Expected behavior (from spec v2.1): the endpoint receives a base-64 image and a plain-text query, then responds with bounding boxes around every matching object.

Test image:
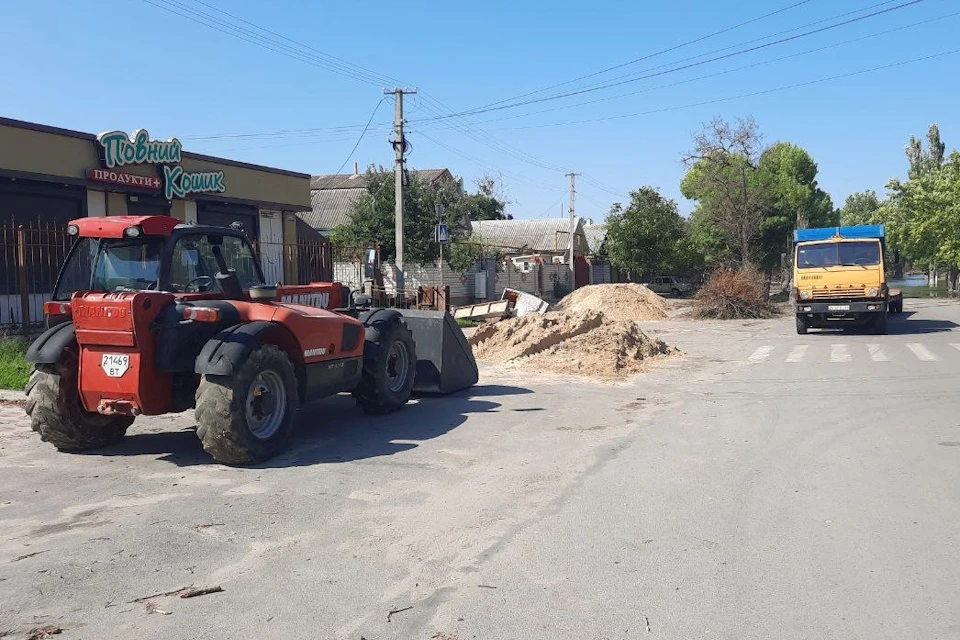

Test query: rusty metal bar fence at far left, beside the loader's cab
[0,220,71,333]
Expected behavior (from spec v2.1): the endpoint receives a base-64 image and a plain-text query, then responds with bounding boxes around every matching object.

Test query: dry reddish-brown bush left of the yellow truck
[693,267,777,320]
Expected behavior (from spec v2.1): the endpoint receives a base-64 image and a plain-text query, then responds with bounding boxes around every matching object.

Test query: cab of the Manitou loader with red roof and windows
[53,216,264,302]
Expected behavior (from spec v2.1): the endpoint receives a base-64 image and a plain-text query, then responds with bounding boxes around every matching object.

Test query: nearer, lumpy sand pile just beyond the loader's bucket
[470,311,679,380]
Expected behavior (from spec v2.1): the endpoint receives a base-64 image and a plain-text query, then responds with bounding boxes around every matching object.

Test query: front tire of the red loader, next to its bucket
[353,319,417,414]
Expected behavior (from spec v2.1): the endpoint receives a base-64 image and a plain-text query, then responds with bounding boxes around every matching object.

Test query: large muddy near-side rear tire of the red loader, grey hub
[194,344,298,465]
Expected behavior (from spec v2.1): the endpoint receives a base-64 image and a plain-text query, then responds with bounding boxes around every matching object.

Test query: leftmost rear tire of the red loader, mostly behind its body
[24,349,133,451]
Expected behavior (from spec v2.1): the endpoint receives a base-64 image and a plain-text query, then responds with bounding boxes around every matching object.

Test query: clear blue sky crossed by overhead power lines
[0,0,960,219]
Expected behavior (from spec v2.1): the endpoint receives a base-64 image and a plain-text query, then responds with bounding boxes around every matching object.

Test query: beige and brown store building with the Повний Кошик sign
[0,118,311,284]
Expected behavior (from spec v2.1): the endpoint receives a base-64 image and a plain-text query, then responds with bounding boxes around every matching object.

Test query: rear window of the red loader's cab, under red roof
[53,238,163,300]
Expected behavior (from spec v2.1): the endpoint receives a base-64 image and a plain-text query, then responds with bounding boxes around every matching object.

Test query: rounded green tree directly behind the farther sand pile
[606,187,684,275]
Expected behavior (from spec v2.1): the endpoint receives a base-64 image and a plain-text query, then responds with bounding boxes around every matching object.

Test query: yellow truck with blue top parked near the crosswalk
[793,225,903,335]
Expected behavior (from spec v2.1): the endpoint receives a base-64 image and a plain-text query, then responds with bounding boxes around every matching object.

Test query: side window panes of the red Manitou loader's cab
[170,234,263,293]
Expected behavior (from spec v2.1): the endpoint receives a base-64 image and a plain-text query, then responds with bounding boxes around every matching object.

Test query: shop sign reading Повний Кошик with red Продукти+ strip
[93,129,227,200]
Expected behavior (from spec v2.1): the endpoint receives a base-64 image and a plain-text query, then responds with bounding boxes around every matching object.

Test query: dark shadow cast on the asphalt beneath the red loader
[83,385,543,469]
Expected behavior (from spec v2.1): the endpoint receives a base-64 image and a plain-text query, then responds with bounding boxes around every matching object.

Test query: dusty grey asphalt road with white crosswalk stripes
[0,301,960,640]
